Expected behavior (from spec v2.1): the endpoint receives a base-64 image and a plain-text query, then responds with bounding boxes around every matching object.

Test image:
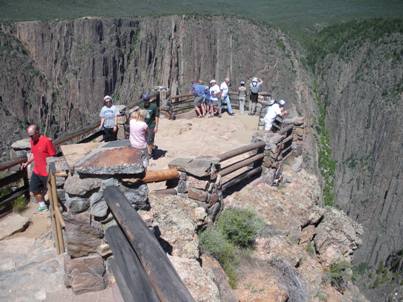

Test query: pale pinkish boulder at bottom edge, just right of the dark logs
[168,256,223,302]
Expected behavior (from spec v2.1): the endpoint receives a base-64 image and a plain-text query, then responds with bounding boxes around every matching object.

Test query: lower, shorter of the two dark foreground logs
[105,226,159,302]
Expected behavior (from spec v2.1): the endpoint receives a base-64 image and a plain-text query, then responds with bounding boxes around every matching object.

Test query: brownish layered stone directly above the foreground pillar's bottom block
[63,212,103,258]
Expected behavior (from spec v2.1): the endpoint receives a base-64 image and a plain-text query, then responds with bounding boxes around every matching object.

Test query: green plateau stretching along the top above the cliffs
[0,0,403,44]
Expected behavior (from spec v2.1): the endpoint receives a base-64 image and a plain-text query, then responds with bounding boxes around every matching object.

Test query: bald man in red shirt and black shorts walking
[22,125,56,211]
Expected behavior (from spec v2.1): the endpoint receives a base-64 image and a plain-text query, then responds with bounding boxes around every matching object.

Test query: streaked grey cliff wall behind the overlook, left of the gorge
[0,16,309,156]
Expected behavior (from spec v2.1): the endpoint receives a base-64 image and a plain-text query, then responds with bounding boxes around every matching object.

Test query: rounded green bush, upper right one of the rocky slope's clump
[217,209,264,248]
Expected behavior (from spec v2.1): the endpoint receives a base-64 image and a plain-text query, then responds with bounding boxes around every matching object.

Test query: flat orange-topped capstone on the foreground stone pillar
[75,142,144,176]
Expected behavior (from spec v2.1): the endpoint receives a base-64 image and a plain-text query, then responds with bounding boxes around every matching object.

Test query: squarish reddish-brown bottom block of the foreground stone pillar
[64,255,106,294]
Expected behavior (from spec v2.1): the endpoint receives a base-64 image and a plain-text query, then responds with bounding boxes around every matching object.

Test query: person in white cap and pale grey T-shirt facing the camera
[99,95,119,142]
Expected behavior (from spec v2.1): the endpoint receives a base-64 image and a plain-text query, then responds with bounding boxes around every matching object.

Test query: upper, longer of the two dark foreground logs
[104,187,194,302]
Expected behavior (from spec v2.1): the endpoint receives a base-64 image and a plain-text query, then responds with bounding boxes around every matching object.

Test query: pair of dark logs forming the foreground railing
[103,187,194,302]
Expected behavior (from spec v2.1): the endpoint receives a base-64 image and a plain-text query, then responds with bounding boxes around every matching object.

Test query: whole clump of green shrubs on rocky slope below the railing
[200,209,264,288]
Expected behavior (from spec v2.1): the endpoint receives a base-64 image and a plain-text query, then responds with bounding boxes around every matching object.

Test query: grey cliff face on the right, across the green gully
[316,21,403,266]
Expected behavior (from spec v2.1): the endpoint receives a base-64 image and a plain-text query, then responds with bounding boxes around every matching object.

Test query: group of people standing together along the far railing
[192,77,263,117]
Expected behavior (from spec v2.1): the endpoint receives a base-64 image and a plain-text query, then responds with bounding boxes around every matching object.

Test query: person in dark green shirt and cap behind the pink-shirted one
[142,93,160,157]
